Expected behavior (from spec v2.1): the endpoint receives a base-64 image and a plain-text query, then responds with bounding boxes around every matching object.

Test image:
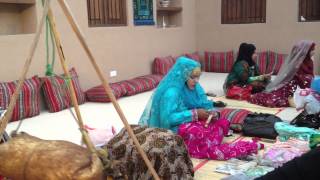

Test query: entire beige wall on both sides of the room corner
[0,0,320,89]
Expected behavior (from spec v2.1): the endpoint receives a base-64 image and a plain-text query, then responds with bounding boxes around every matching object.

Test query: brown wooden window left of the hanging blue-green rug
[87,0,127,27]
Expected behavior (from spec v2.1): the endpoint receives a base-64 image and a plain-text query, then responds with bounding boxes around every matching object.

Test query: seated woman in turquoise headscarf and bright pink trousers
[139,57,260,160]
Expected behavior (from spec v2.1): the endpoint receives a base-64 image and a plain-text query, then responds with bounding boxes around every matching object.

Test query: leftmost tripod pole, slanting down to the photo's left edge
[0,0,50,136]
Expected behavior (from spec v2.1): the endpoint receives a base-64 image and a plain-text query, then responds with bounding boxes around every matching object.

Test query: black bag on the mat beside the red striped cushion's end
[242,113,282,139]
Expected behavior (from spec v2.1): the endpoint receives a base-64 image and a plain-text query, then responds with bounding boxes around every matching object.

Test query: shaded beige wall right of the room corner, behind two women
[196,0,320,73]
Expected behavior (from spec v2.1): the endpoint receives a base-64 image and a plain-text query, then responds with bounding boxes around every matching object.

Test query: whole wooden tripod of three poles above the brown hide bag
[0,0,160,180]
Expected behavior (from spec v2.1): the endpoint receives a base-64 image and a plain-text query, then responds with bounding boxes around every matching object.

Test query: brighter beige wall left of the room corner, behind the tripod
[0,0,196,89]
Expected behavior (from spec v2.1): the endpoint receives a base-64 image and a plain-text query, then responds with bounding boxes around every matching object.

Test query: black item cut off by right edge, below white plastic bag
[290,111,320,129]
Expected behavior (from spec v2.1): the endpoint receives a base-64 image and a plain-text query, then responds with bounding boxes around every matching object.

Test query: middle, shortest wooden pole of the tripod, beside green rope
[48,8,97,155]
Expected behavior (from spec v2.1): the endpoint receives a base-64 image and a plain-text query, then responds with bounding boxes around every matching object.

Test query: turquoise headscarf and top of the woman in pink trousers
[139,57,212,131]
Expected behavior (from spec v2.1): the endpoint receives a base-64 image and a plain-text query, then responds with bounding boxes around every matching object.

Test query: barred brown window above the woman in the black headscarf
[221,0,266,24]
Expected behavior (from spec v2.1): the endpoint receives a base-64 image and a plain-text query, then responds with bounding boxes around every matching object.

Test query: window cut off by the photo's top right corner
[299,0,320,21]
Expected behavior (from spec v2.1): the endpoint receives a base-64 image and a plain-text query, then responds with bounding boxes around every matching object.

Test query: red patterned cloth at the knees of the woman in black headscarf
[226,85,252,100]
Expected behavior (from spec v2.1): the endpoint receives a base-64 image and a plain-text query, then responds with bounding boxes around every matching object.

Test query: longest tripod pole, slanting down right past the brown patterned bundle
[58,0,160,180]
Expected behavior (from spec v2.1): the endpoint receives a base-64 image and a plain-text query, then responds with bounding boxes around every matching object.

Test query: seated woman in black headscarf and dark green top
[223,43,271,98]
